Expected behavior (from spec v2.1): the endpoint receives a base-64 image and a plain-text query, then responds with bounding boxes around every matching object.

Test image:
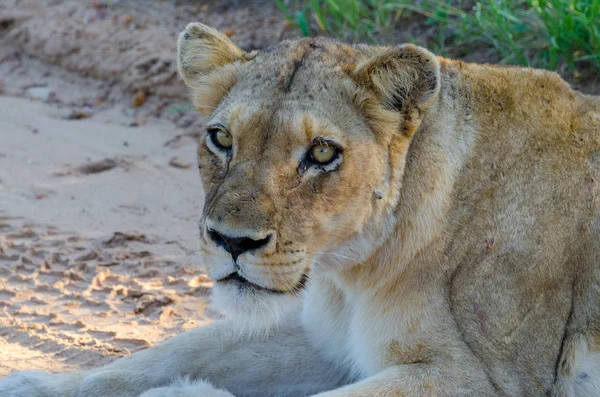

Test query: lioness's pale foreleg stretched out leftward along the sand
[0,317,344,397]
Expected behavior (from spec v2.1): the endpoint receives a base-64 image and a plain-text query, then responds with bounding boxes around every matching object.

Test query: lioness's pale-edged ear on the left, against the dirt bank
[177,23,245,86]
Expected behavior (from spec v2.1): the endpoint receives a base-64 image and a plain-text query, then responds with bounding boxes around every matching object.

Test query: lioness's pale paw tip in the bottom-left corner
[0,371,77,397]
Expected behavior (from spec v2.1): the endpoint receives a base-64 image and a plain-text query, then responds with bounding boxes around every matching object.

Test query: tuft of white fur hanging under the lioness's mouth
[211,283,300,335]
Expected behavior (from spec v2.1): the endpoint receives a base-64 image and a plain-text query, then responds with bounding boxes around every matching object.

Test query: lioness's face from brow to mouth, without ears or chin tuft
[198,84,387,302]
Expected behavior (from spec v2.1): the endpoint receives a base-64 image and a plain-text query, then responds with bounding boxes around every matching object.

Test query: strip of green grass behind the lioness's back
[275,0,600,75]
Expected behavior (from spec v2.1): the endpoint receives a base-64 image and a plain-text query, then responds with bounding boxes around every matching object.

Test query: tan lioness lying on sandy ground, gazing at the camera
[0,23,600,397]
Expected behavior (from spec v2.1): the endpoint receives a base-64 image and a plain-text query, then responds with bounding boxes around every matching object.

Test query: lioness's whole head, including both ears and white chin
[178,24,438,324]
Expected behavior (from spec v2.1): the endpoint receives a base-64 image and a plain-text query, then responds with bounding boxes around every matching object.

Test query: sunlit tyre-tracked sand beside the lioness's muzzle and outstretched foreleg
[0,220,212,376]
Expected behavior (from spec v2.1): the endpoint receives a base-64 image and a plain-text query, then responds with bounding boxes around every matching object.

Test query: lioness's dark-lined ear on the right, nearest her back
[351,44,440,135]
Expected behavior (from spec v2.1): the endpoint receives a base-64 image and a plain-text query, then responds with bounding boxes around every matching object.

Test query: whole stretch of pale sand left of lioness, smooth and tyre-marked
[0,97,211,376]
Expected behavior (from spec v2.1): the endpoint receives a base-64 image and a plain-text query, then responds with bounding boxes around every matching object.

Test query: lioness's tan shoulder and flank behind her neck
[436,61,600,394]
